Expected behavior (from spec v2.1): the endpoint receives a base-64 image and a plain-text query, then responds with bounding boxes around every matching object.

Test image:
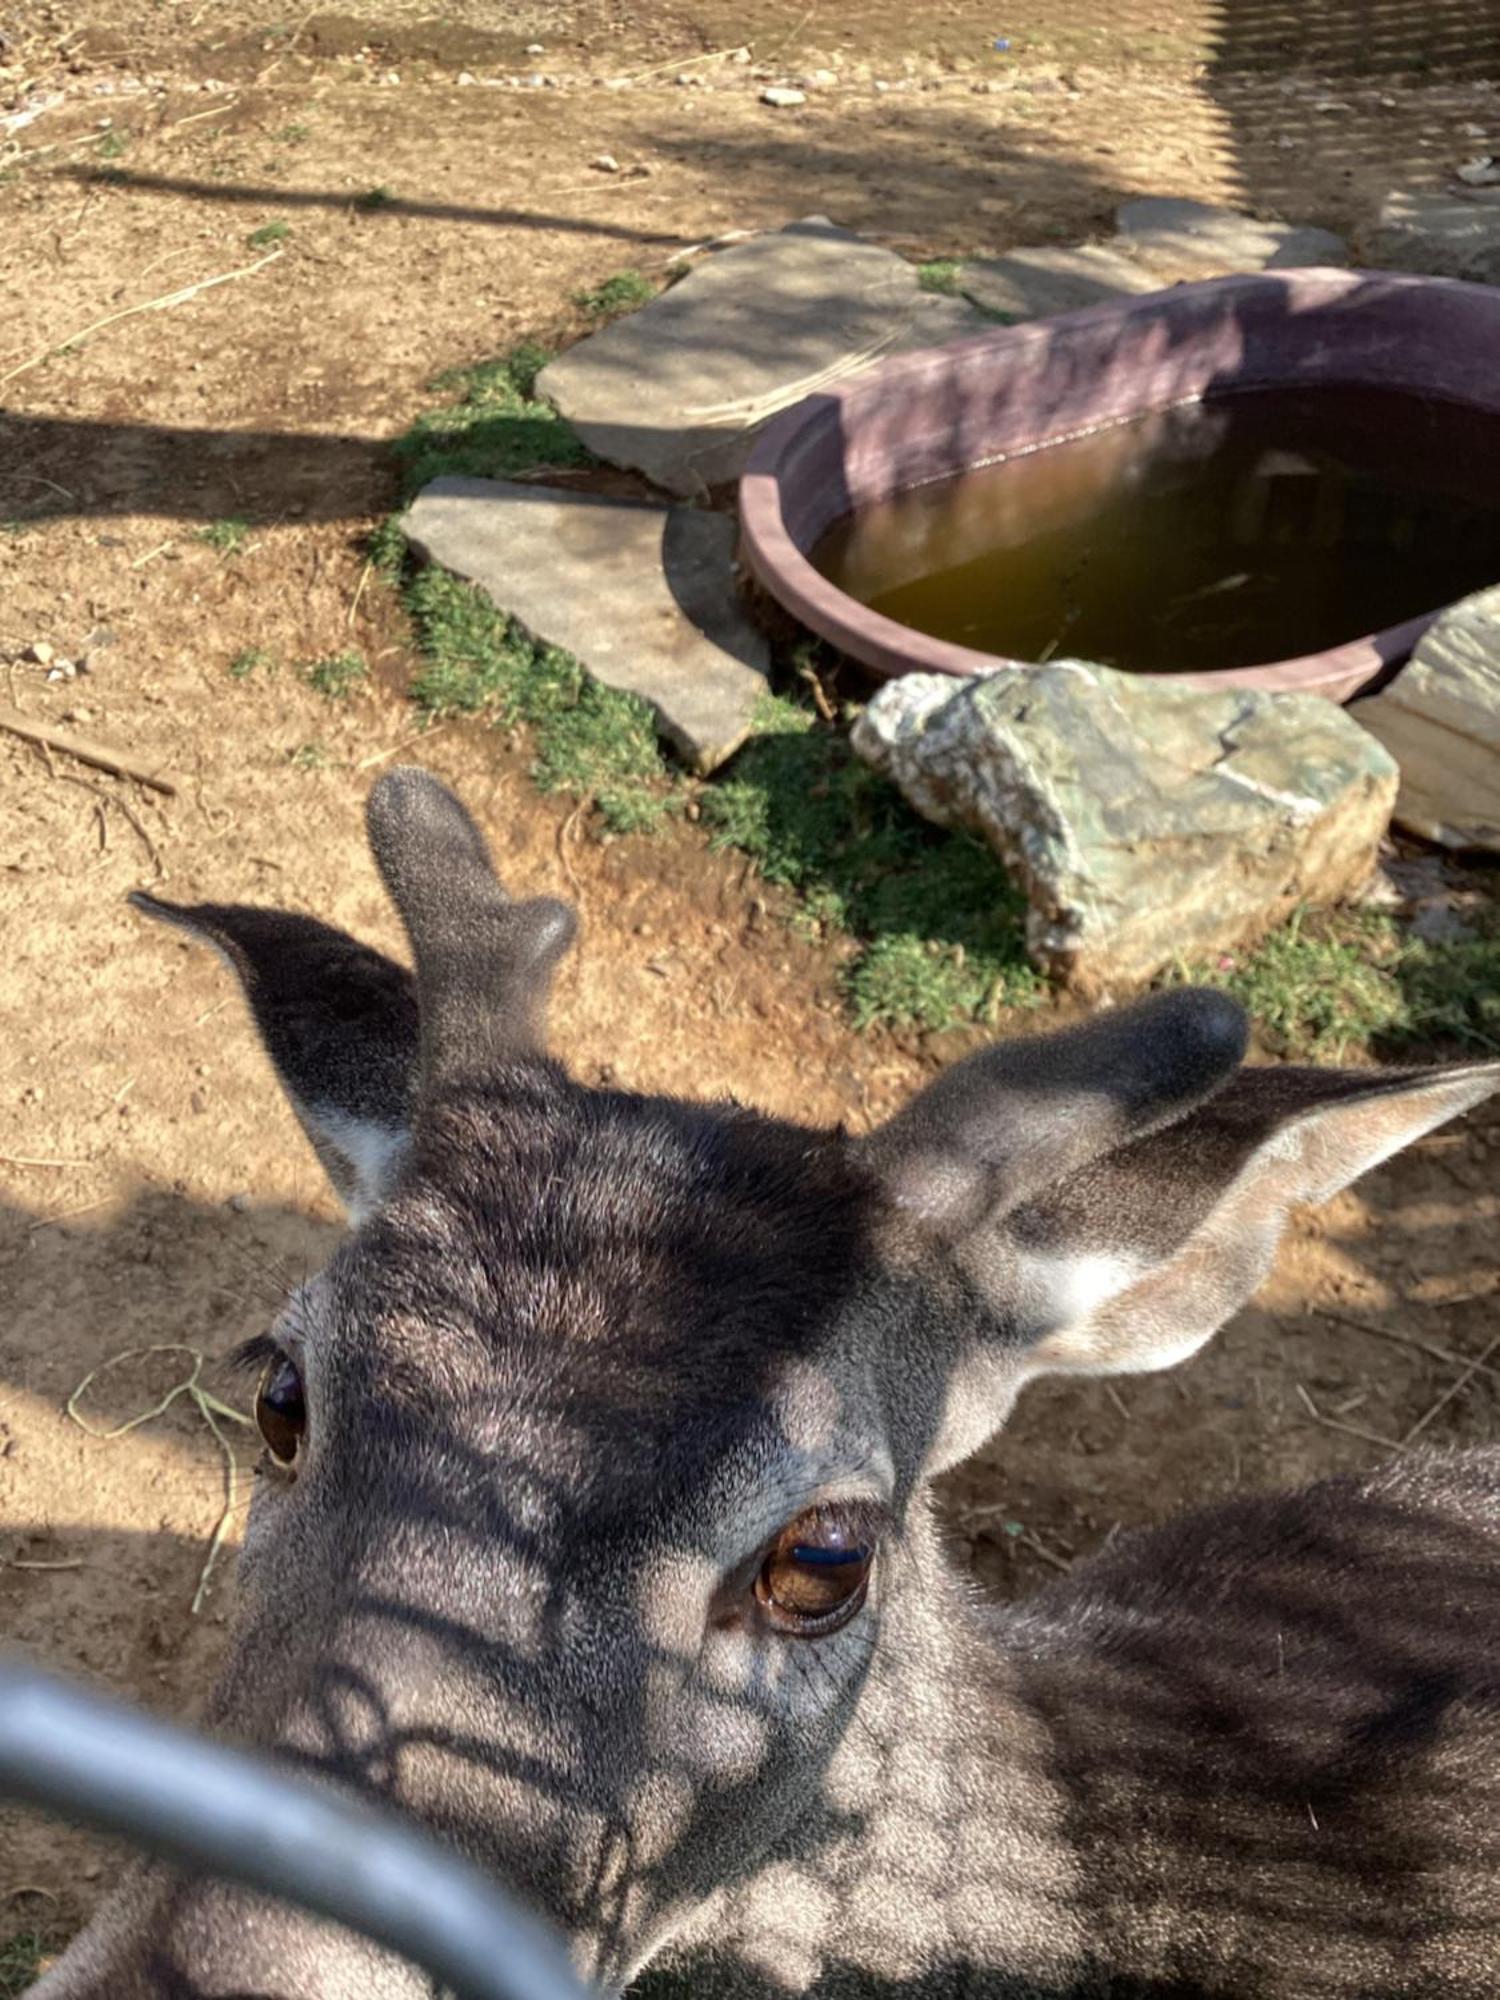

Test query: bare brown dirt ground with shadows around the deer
[0,0,1500,1968]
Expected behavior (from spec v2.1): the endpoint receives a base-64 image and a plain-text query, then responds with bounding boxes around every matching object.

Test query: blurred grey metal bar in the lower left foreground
[0,1660,586,2000]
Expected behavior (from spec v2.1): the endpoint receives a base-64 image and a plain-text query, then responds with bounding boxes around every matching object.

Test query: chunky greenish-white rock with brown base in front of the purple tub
[854,660,1396,996]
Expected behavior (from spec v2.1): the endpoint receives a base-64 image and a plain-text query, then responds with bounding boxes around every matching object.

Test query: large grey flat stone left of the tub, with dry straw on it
[538,218,940,496]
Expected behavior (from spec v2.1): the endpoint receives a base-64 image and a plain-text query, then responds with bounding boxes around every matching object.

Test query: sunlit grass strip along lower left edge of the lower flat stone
[406,568,682,834]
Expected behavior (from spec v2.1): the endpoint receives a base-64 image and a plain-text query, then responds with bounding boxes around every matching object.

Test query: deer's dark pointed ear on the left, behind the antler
[130,890,418,1222]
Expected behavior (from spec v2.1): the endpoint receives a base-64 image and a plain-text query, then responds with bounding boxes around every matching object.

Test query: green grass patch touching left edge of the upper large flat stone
[396,346,594,500]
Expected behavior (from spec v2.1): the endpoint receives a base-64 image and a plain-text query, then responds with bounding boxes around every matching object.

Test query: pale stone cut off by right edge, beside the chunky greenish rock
[1352,586,1500,854]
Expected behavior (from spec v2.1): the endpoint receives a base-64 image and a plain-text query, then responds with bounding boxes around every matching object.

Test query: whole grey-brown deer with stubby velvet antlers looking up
[38,770,1500,2000]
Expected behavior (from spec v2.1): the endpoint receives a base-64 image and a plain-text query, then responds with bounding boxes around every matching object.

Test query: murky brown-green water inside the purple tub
[814,390,1500,674]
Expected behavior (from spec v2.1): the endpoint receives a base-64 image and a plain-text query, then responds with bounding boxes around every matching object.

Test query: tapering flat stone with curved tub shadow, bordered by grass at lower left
[402,478,770,772]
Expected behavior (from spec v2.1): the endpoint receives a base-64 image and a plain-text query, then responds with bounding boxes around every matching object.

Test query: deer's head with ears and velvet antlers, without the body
[35,770,1496,2000]
